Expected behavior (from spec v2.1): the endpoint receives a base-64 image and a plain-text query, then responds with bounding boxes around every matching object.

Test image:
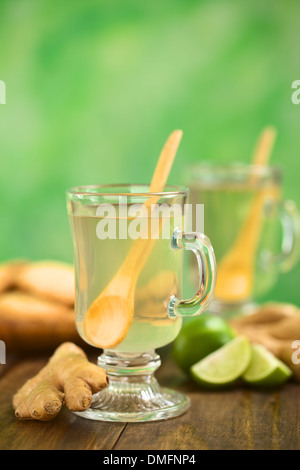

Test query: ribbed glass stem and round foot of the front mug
[76,350,190,422]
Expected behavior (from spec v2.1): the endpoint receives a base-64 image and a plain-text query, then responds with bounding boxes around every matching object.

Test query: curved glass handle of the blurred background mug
[262,201,300,272]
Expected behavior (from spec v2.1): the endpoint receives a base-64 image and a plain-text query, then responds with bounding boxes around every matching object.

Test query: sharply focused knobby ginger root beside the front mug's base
[13,343,108,421]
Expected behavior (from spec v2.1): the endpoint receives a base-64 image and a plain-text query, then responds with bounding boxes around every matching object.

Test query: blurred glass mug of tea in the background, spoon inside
[188,164,300,314]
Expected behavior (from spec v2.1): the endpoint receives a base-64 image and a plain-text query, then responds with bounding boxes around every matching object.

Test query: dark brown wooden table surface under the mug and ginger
[0,350,300,450]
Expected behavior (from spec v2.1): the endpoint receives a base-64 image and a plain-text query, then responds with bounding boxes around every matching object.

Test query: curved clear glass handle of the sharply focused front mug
[168,230,217,318]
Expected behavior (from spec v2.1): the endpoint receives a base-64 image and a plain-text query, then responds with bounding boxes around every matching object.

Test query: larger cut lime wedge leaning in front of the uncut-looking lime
[191,336,251,388]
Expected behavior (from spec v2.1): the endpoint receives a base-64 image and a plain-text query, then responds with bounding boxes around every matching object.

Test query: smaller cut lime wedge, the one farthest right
[243,344,292,387]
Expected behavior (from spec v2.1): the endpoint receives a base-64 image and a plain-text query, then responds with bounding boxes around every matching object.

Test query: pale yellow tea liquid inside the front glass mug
[70,206,183,354]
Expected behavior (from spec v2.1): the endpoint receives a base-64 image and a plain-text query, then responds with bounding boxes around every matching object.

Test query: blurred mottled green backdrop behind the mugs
[0,0,300,304]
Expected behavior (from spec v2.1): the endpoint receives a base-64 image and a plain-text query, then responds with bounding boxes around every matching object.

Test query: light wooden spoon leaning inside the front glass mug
[84,130,182,348]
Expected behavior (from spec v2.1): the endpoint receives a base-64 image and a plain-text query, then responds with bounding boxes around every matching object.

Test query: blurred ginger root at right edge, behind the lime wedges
[229,303,300,382]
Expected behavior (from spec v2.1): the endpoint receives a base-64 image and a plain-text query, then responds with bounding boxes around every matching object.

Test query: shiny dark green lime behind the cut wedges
[172,313,235,373]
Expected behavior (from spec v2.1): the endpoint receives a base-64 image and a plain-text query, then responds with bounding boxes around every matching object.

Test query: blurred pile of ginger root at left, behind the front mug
[0,260,83,352]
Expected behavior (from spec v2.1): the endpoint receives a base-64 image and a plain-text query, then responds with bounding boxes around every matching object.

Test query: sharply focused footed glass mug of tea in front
[67,185,216,422]
